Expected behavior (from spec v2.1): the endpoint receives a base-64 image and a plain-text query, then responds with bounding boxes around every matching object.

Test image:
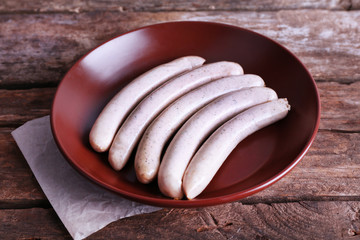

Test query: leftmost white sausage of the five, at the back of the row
[89,56,205,152]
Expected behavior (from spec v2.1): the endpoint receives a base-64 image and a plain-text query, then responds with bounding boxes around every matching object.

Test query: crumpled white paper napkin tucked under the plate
[11,116,160,240]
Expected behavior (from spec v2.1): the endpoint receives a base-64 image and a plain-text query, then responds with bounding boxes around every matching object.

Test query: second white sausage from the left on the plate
[109,62,243,170]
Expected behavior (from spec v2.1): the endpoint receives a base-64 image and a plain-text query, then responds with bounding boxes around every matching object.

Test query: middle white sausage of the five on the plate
[135,74,264,183]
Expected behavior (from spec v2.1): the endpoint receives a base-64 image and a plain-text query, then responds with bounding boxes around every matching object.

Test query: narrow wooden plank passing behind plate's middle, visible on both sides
[0,81,360,132]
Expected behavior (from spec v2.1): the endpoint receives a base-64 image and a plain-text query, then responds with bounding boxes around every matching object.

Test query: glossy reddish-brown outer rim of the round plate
[50,20,321,208]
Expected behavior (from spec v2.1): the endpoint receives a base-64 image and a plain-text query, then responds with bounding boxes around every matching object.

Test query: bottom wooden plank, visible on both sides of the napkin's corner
[0,201,360,240]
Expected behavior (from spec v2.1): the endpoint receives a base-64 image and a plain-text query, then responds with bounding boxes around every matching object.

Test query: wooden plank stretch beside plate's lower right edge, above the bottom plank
[243,131,360,203]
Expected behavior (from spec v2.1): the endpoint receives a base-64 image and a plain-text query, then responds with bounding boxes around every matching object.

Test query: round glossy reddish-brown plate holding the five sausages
[51,22,320,207]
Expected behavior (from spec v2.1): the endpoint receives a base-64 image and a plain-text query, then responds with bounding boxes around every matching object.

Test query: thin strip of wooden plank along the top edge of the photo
[0,0,357,13]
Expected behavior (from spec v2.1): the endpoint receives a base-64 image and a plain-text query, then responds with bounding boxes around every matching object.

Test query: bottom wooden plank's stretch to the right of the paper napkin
[89,202,360,240]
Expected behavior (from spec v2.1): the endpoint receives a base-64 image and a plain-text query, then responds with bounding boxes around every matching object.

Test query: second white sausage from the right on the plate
[158,87,277,199]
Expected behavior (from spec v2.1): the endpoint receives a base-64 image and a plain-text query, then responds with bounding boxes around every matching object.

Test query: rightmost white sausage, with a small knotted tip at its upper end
[183,99,290,199]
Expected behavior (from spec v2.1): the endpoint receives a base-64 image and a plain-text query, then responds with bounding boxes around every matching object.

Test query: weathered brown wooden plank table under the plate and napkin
[0,0,360,239]
